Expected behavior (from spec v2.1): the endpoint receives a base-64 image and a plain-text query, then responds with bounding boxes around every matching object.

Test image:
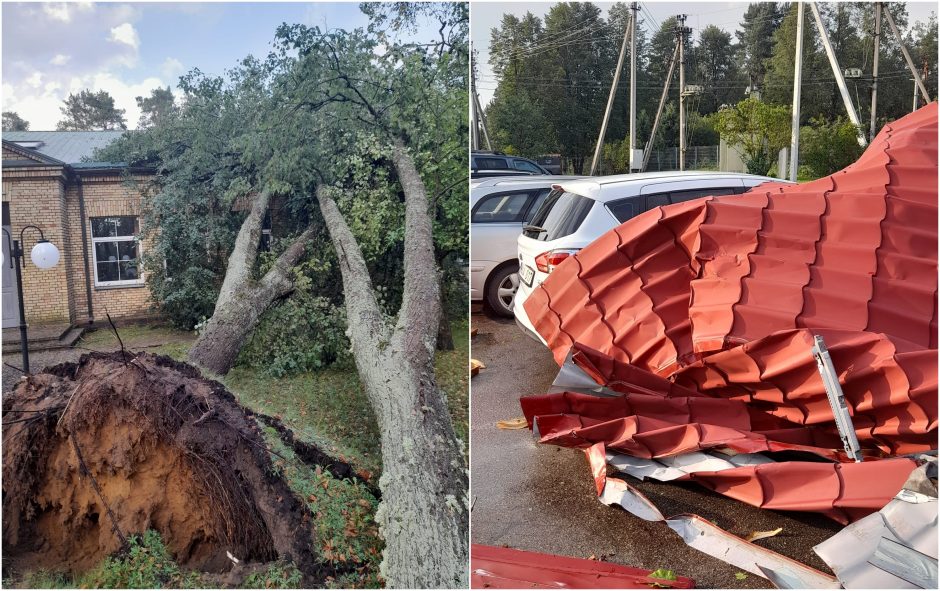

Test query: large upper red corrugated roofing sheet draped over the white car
[524,103,937,376]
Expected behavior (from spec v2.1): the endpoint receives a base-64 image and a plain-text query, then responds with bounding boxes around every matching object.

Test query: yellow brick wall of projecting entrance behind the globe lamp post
[3,167,70,323]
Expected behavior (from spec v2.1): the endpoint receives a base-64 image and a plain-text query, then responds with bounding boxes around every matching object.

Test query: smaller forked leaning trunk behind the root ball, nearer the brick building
[187,192,313,375]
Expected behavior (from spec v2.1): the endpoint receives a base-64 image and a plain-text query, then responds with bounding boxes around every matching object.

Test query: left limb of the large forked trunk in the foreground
[317,186,388,358]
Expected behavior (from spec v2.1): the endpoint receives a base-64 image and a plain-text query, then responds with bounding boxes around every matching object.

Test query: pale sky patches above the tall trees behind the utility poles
[470,0,937,106]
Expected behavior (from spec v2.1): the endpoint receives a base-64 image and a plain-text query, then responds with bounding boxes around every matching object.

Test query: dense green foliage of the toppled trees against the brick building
[98,4,469,373]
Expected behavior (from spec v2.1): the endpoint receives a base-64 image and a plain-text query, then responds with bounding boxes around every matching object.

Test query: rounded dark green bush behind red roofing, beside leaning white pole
[800,117,864,178]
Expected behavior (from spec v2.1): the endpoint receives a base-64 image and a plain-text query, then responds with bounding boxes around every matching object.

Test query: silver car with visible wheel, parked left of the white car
[470,175,581,318]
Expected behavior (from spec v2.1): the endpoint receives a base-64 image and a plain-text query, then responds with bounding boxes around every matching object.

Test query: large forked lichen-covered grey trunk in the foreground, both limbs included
[317,142,469,588]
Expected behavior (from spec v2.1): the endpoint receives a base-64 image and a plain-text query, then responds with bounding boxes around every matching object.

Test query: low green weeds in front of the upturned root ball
[78,530,198,589]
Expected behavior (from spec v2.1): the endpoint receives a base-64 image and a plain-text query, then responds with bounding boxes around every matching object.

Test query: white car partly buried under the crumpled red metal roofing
[516,171,784,344]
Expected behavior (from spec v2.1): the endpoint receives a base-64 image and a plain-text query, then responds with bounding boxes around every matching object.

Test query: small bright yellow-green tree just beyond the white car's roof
[710,98,790,175]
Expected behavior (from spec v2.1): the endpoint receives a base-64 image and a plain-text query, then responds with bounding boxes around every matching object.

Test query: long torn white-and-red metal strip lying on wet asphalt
[585,443,839,589]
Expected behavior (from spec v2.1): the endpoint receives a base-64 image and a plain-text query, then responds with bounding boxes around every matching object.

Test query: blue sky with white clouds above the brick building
[2,2,384,131]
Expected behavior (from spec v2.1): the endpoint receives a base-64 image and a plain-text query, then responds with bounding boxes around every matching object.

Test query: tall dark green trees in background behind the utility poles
[480,2,938,173]
